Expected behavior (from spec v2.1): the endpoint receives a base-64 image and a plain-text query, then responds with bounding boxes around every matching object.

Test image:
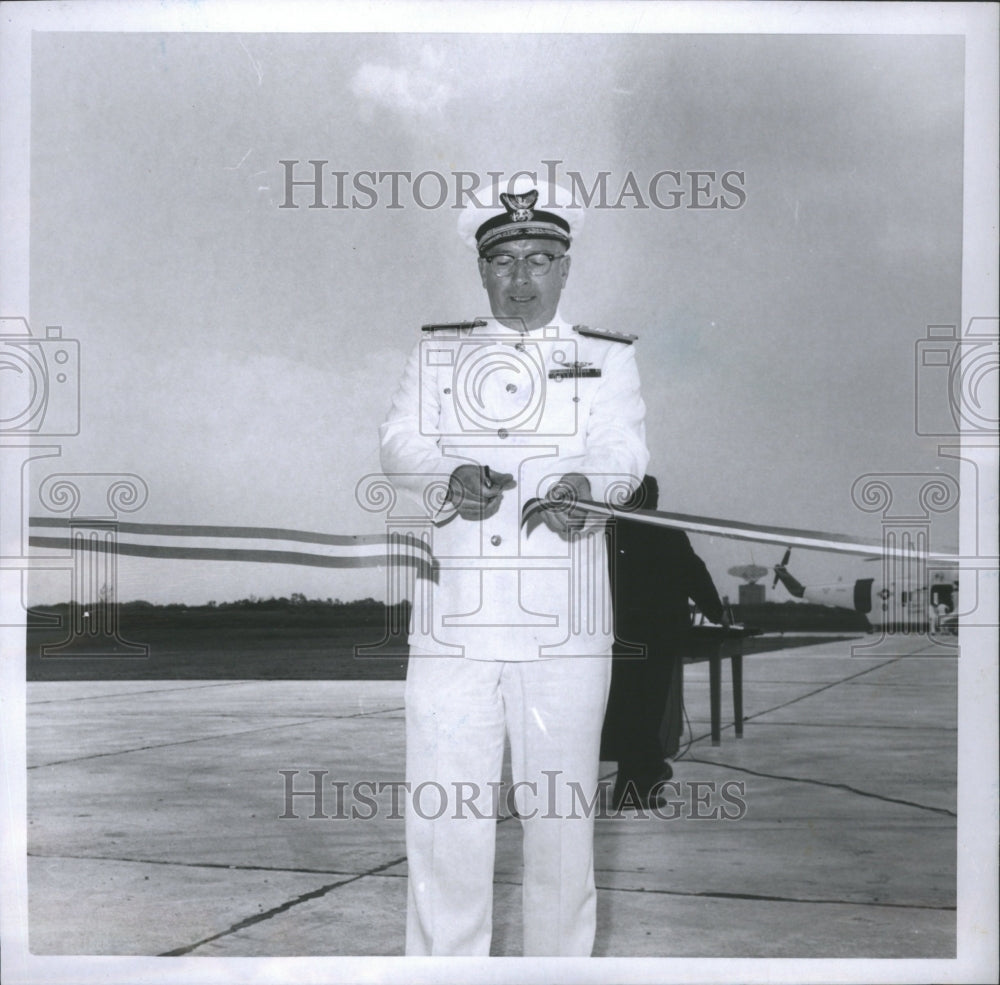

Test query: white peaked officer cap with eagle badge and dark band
[458,173,584,254]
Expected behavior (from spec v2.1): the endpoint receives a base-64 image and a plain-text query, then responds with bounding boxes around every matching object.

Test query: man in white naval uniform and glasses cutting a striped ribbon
[381,179,648,955]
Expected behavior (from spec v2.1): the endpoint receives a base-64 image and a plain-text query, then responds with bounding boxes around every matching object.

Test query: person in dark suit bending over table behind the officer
[601,475,727,811]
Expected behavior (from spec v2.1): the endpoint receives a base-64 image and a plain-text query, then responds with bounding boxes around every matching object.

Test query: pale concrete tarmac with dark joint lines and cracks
[27,639,958,956]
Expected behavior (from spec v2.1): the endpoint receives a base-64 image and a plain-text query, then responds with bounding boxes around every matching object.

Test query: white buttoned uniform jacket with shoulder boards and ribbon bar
[381,316,649,660]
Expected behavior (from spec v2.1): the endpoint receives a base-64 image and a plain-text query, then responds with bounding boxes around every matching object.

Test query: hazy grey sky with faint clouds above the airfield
[21,32,964,604]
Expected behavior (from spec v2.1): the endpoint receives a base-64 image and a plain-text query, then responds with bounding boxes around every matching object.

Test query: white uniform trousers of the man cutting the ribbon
[406,649,611,956]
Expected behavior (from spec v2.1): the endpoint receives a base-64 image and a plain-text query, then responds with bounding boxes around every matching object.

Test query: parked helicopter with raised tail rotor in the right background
[771,547,958,633]
